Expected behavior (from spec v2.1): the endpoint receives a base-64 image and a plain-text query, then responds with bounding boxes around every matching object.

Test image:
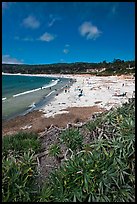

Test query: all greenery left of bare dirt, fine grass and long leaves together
[2,133,40,202]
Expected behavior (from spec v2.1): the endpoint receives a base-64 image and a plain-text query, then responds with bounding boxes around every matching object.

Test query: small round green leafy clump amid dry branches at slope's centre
[60,128,83,151]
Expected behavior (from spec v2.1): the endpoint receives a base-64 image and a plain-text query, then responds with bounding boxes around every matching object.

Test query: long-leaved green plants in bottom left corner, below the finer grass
[2,151,37,202]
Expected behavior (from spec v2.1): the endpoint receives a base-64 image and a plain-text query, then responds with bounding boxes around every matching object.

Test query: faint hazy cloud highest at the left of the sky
[22,15,40,29]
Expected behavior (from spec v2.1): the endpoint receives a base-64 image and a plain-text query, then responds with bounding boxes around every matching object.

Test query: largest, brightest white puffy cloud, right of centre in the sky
[79,22,102,40]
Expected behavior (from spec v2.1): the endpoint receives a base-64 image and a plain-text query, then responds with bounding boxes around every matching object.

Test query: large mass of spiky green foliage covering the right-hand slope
[41,100,135,202]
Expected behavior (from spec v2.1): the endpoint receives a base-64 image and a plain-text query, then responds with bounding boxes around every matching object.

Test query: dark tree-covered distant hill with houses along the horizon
[2,59,135,75]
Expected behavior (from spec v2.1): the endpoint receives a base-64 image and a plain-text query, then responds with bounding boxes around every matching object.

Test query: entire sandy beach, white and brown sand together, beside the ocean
[2,74,135,135]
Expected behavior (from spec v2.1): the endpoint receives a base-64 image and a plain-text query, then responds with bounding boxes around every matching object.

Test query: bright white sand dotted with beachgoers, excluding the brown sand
[40,75,135,117]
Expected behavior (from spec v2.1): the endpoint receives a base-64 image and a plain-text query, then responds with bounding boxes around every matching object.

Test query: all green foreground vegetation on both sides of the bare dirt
[2,99,135,202]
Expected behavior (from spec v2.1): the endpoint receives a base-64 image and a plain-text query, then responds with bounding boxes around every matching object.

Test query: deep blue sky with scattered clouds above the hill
[2,2,135,64]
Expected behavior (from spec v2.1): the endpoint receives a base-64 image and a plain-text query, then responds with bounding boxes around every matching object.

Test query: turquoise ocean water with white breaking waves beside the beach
[2,74,70,120]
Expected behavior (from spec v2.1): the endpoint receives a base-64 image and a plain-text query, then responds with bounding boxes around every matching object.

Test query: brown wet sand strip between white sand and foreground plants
[2,106,105,136]
